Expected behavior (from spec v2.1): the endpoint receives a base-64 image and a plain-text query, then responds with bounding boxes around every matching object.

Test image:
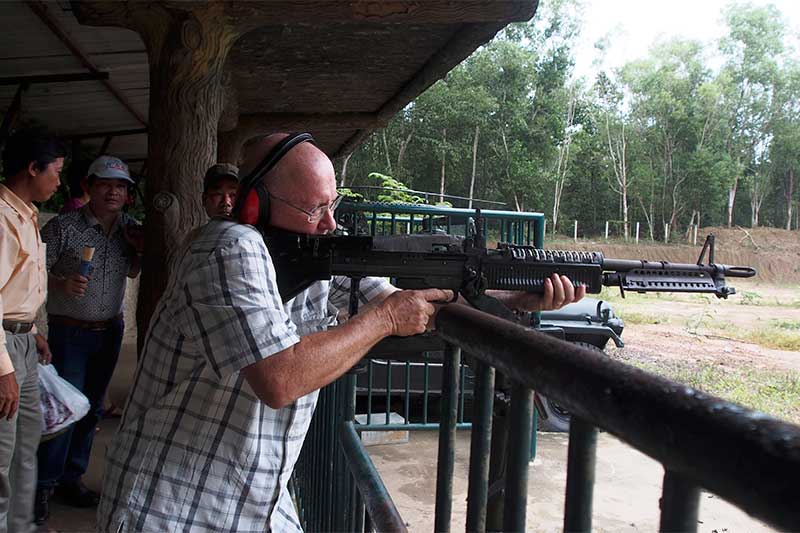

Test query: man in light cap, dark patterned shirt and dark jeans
[34,155,143,524]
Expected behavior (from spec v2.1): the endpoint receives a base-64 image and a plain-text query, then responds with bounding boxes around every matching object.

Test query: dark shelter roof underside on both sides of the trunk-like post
[0,0,537,174]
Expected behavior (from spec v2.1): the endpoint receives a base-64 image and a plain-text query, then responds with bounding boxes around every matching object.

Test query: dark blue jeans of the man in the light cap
[38,320,125,488]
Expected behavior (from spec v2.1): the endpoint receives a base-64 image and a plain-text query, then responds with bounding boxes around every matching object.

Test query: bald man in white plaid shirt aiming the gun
[98,134,583,532]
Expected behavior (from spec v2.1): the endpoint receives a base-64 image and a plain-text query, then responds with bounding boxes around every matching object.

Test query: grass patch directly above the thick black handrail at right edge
[617,356,800,424]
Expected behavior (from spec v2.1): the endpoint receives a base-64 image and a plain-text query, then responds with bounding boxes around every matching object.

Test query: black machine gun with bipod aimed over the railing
[264,224,756,319]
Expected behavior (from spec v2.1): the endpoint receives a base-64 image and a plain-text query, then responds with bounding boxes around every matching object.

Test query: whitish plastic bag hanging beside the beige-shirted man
[39,364,89,435]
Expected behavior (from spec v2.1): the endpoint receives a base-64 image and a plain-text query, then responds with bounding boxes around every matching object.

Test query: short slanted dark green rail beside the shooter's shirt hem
[339,421,408,532]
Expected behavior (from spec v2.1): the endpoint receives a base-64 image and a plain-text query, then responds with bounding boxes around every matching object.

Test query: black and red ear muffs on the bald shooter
[233,133,316,229]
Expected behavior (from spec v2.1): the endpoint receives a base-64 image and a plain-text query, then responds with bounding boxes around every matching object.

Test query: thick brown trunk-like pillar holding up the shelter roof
[136,10,237,348]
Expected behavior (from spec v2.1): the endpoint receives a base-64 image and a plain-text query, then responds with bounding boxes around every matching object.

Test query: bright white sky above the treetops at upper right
[568,0,800,79]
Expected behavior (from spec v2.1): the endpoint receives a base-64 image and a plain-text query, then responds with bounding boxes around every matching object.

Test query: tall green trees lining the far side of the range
[340,0,800,238]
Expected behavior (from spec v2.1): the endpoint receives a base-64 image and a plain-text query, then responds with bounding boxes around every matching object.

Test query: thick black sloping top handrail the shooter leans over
[436,305,800,530]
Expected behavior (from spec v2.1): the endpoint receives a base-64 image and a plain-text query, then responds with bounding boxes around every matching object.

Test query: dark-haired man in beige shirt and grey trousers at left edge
[0,130,65,533]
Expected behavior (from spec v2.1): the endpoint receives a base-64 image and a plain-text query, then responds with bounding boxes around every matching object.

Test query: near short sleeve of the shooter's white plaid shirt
[180,233,300,379]
